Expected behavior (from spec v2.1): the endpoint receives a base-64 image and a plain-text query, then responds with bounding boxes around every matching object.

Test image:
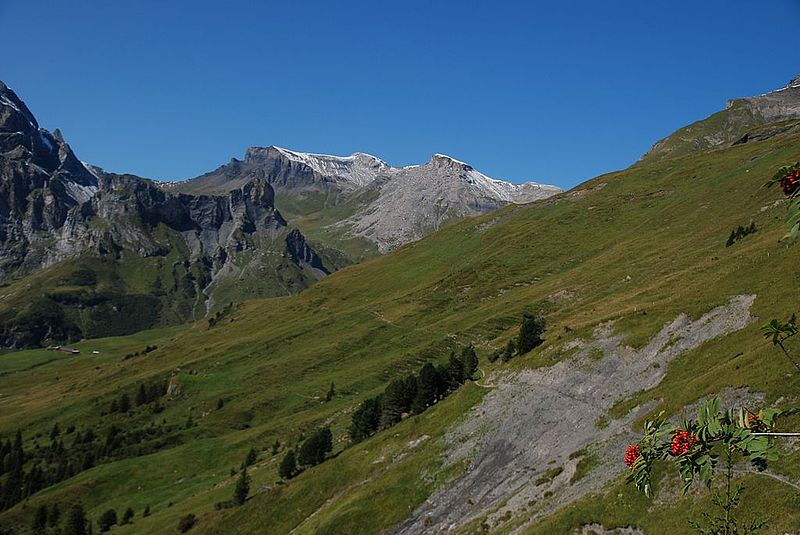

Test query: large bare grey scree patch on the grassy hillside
[394,295,755,534]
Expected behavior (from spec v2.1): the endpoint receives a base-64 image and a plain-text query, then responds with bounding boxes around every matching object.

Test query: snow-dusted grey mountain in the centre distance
[175,147,561,254]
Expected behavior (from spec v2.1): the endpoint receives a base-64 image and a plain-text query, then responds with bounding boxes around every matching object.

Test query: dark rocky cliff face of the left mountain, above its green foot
[0,82,329,345]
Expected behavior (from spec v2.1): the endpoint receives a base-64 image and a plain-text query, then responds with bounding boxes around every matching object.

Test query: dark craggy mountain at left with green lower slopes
[0,79,330,347]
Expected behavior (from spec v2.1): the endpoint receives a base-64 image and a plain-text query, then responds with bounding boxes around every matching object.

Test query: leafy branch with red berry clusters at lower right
[624,398,781,496]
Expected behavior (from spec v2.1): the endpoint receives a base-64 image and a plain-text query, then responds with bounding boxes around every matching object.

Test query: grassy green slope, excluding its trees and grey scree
[0,126,800,533]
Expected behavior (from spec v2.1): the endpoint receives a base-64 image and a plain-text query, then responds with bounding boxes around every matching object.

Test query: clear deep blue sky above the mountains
[0,0,800,186]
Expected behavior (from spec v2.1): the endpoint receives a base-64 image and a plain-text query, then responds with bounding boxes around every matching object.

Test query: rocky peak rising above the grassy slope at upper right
[642,76,800,161]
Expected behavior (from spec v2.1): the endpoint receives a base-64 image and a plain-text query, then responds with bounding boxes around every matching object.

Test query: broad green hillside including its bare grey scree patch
[0,76,800,535]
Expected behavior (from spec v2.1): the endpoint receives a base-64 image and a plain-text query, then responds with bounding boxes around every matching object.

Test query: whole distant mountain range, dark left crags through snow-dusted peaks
[0,82,561,347]
